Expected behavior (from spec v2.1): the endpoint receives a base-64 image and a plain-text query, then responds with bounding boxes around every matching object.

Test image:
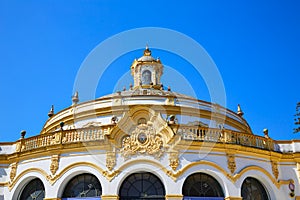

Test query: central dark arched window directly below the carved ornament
[119,172,166,200]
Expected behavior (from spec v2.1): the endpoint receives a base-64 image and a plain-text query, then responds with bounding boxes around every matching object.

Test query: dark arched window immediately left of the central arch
[62,174,102,200]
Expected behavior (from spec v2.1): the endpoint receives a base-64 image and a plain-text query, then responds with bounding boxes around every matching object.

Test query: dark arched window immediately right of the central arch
[182,173,224,200]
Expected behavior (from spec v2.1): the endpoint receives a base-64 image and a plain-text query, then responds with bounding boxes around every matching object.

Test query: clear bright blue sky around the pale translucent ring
[0,0,300,142]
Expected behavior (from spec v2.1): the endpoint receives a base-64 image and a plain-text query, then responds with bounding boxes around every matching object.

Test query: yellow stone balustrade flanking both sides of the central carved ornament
[5,125,280,152]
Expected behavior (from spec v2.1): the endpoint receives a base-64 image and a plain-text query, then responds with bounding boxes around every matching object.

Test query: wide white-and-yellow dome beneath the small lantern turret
[41,86,252,135]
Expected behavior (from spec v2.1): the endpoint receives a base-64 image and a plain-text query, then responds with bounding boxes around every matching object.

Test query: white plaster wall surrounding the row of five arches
[0,150,300,200]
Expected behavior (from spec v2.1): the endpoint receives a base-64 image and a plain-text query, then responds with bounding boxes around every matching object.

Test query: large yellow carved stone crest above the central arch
[120,122,164,159]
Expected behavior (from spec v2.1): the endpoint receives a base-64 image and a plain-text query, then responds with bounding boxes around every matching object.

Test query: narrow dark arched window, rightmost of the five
[242,177,269,200]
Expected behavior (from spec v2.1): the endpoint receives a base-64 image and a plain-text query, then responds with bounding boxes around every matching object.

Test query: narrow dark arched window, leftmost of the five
[20,178,45,200]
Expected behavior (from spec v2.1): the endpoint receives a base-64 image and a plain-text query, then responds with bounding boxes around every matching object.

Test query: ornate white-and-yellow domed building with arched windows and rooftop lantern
[0,48,300,200]
